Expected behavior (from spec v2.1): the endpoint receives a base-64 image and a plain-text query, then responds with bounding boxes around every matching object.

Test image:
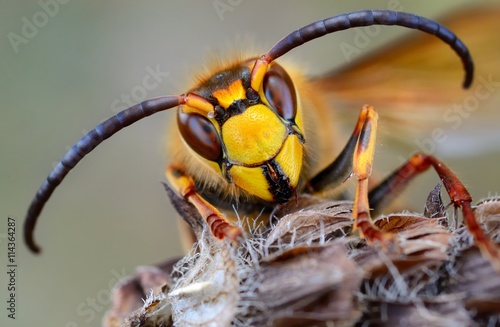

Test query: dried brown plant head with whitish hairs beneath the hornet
[104,188,500,327]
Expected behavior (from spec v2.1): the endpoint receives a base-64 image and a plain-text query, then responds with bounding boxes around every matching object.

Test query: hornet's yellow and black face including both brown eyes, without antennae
[178,63,304,203]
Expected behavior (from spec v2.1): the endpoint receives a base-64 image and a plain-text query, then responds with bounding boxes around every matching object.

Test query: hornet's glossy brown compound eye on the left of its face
[177,109,222,162]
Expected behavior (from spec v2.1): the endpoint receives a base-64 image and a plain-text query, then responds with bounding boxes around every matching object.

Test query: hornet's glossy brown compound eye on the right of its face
[263,64,297,121]
